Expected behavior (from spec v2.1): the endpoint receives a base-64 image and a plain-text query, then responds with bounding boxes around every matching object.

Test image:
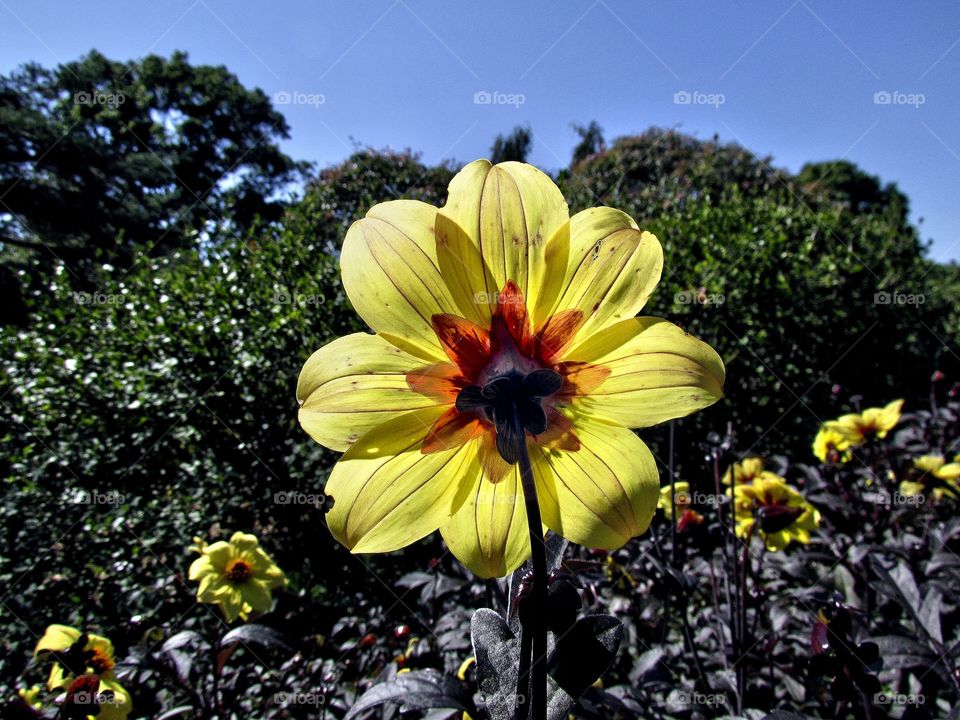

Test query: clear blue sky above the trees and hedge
[0,0,960,260]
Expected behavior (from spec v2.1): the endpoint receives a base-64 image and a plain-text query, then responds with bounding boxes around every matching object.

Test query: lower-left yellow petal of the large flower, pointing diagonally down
[325,408,480,553]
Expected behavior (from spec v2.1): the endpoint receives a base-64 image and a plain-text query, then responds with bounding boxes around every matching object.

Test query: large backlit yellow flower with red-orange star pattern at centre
[297,160,724,577]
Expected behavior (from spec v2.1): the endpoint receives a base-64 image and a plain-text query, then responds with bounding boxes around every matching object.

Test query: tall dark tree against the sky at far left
[0,51,303,284]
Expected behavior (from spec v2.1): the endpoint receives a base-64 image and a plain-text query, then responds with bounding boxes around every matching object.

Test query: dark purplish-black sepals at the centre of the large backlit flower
[456,368,563,465]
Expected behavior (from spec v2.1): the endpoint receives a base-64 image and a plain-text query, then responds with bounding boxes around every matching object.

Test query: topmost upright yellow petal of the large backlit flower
[440,160,569,320]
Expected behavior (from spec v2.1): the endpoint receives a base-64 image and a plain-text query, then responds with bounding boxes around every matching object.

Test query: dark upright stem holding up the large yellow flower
[513,411,547,720]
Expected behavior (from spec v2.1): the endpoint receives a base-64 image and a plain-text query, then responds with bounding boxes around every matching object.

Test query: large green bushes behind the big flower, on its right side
[561,131,960,462]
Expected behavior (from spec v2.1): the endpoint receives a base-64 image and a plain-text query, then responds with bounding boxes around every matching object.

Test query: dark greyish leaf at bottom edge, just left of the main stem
[344,668,477,720]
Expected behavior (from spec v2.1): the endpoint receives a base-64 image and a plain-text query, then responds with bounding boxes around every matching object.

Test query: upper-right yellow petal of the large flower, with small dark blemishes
[552,207,663,338]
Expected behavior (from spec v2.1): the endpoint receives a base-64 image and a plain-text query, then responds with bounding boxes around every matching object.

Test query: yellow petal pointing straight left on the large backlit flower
[297,333,446,452]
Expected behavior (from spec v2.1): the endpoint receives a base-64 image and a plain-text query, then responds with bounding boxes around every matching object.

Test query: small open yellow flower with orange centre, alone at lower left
[190,532,287,622]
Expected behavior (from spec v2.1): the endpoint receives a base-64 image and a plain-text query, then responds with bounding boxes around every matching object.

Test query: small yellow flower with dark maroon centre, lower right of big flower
[734,478,820,551]
